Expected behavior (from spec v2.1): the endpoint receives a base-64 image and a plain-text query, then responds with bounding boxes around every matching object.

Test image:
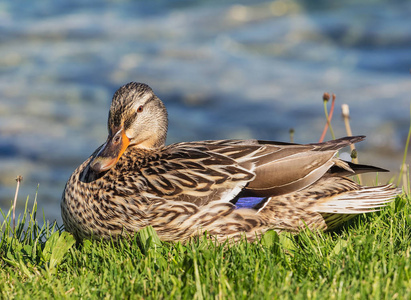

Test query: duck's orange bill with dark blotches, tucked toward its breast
[90,131,130,173]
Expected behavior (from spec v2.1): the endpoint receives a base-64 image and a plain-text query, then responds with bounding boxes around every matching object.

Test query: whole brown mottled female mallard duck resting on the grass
[61,82,398,241]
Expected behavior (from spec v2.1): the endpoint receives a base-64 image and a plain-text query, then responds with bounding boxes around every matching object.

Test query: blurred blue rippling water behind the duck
[0,0,411,224]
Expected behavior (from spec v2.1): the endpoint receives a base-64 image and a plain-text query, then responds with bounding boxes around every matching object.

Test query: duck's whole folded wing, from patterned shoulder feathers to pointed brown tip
[140,137,363,205]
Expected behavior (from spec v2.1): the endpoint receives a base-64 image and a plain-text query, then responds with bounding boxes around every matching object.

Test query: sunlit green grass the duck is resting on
[0,191,411,299]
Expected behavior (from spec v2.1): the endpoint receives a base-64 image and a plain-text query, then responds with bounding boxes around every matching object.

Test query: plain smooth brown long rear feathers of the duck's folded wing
[211,136,365,196]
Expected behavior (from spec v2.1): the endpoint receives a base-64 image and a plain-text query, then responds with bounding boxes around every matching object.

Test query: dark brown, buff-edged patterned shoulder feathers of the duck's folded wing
[138,143,255,206]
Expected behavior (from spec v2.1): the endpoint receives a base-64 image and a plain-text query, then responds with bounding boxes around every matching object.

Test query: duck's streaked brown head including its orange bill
[90,82,168,173]
